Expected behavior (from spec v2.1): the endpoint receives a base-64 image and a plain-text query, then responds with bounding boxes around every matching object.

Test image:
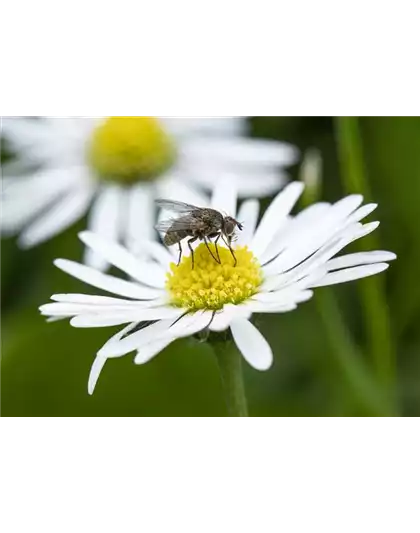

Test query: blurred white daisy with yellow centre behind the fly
[0,112,297,269]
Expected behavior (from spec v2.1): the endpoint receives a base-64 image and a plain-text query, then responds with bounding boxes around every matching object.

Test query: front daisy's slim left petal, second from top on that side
[54,259,162,300]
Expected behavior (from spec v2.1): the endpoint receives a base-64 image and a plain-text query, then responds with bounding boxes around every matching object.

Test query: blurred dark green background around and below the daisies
[0,115,420,419]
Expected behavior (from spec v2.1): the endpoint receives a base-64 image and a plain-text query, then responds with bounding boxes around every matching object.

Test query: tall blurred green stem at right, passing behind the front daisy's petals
[335,115,396,389]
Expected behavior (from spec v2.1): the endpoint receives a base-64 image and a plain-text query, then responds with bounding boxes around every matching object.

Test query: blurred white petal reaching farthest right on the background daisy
[181,137,299,166]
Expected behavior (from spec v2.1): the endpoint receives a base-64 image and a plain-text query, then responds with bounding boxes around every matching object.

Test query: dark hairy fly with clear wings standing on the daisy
[156,200,242,268]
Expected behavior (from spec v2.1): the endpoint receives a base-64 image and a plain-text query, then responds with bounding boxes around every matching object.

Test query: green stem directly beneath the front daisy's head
[211,340,248,422]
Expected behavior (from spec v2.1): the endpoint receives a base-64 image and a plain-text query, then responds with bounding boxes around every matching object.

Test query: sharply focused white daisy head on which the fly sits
[40,182,396,394]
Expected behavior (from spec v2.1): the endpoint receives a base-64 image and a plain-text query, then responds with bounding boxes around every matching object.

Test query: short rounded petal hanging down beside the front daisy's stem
[230,318,273,370]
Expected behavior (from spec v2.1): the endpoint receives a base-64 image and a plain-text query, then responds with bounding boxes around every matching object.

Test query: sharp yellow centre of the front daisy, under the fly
[166,244,262,311]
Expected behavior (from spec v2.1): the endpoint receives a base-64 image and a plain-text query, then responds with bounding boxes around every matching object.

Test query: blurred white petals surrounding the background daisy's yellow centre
[1,112,298,271]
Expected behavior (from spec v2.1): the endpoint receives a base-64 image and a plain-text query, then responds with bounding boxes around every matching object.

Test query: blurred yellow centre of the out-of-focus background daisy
[88,116,176,184]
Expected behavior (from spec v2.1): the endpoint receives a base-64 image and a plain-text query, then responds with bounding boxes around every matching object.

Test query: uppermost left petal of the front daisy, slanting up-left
[79,231,165,289]
